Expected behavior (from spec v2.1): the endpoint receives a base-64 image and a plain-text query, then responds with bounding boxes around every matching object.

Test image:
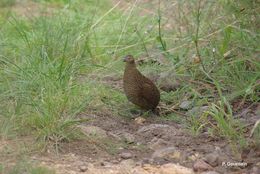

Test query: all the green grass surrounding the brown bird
[0,0,260,154]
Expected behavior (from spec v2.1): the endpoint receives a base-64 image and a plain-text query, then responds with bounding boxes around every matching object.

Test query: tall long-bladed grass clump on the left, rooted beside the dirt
[1,10,95,142]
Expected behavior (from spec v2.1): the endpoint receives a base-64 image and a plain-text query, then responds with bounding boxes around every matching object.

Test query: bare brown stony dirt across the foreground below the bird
[0,1,260,174]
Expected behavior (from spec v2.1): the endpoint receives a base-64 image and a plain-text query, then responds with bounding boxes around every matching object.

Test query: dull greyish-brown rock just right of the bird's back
[158,71,181,92]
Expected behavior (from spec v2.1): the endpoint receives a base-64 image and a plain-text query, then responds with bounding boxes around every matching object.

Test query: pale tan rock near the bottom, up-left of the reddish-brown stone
[152,147,180,159]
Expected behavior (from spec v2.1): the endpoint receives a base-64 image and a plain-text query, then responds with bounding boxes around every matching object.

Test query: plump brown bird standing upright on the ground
[123,55,160,115]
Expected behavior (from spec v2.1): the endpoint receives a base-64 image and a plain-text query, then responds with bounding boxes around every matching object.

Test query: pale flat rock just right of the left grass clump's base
[78,125,107,138]
